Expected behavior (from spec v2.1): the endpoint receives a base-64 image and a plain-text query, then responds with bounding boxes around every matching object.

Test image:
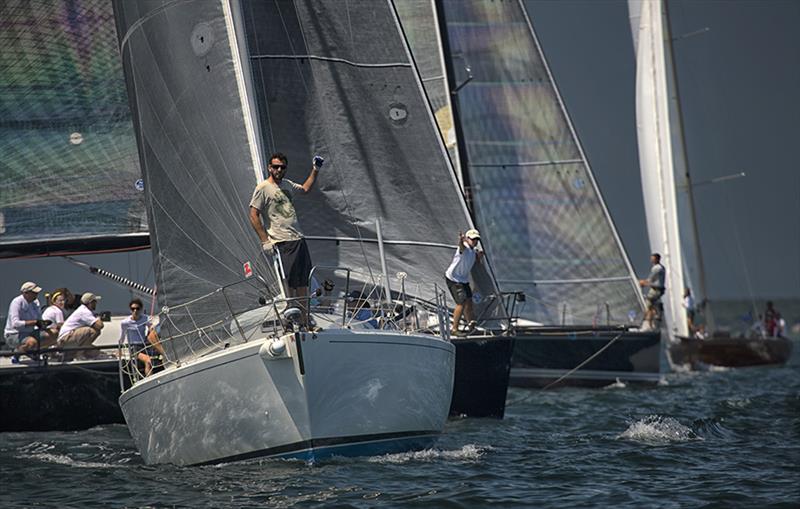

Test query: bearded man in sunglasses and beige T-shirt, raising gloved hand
[250,152,324,324]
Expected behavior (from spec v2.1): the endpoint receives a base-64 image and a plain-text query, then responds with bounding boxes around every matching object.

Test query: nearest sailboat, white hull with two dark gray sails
[114,0,502,465]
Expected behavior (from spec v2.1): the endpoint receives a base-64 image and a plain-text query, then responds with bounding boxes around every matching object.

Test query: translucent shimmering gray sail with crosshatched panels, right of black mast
[434,0,642,324]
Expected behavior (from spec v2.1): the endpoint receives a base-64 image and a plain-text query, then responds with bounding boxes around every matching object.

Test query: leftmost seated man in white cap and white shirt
[3,281,56,353]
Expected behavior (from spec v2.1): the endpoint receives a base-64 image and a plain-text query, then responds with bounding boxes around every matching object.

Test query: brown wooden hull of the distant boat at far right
[667,336,792,369]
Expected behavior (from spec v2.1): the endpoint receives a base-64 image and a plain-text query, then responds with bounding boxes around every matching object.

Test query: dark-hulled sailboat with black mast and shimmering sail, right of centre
[404,0,661,387]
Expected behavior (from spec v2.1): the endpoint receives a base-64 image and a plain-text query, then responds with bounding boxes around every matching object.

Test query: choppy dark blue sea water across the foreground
[0,341,800,508]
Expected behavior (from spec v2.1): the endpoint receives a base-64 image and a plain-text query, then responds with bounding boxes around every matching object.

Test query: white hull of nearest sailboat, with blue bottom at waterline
[120,329,455,465]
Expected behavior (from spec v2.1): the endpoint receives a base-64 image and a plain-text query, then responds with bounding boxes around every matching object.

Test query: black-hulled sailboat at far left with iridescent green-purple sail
[0,2,149,431]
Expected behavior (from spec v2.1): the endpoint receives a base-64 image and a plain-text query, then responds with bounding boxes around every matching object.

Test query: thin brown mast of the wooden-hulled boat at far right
[661,0,714,331]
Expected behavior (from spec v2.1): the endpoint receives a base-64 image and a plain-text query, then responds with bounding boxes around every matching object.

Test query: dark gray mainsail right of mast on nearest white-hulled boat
[242,0,504,318]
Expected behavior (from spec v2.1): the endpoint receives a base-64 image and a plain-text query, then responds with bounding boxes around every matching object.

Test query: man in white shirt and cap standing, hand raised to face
[444,228,483,335]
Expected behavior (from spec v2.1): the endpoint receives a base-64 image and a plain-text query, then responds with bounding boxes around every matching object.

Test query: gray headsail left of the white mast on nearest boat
[114,1,279,361]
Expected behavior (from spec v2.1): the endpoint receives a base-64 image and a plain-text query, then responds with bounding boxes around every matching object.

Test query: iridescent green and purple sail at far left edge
[0,0,149,257]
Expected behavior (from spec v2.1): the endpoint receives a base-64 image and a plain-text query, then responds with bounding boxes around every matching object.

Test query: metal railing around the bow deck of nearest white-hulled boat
[115,266,460,385]
